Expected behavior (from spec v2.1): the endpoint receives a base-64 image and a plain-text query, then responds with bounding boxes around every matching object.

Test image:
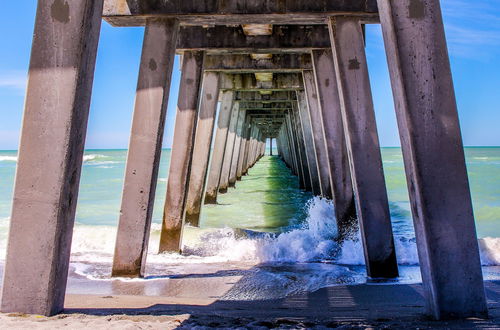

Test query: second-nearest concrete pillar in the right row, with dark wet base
[329,18,398,278]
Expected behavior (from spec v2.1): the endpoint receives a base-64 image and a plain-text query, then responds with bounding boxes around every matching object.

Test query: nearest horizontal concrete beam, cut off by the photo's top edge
[103,0,378,26]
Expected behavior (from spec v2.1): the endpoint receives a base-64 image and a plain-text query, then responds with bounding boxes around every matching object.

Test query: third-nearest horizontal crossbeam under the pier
[204,54,312,73]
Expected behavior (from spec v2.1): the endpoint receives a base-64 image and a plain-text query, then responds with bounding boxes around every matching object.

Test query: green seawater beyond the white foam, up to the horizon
[0,147,500,237]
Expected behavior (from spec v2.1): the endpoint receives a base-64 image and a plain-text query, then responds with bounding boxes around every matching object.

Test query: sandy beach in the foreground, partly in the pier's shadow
[0,282,500,330]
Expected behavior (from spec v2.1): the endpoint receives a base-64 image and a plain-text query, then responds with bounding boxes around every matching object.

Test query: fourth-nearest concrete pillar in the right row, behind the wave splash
[302,70,333,199]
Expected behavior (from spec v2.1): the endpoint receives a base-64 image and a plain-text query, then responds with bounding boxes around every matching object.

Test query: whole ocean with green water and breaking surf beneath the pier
[0,147,500,300]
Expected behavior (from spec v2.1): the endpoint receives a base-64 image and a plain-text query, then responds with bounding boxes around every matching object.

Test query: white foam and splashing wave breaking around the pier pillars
[0,198,500,279]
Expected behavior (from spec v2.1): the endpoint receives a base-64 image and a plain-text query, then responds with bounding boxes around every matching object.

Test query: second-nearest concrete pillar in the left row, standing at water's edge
[111,19,179,277]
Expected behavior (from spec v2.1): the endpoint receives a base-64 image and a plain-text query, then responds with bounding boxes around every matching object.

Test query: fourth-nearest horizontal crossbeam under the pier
[221,73,304,92]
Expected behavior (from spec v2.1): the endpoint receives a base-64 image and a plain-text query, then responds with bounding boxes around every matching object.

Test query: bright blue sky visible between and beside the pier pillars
[0,0,500,150]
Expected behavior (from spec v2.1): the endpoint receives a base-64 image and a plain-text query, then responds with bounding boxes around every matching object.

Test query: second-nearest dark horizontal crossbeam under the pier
[177,25,331,54]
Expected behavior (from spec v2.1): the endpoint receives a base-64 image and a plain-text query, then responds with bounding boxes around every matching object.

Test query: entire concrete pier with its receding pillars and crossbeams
[1,0,487,319]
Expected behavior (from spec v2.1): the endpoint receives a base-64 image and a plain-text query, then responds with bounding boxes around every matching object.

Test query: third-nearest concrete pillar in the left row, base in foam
[159,52,203,252]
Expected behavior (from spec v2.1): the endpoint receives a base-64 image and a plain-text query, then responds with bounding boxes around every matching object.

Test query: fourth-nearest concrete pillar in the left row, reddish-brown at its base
[186,72,219,227]
